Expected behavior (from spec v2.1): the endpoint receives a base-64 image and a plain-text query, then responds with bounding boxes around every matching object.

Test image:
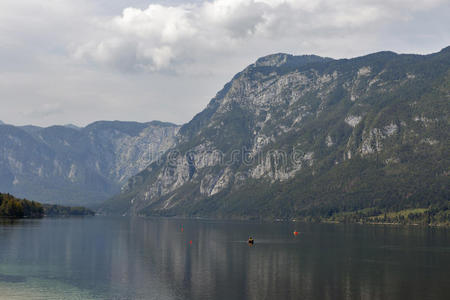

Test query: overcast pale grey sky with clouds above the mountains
[0,0,450,126]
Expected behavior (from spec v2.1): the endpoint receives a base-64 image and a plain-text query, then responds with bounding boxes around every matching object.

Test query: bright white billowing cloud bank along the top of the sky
[74,0,443,72]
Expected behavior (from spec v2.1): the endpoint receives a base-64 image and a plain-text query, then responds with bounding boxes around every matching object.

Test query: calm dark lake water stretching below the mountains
[0,217,450,300]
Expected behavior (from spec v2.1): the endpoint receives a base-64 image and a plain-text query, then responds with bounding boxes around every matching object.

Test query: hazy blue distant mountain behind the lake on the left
[0,121,179,205]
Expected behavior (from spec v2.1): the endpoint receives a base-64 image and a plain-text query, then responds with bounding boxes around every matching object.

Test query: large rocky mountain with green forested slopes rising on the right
[102,47,450,219]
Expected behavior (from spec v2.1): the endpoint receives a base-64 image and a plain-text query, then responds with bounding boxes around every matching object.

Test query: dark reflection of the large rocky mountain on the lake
[109,219,450,299]
